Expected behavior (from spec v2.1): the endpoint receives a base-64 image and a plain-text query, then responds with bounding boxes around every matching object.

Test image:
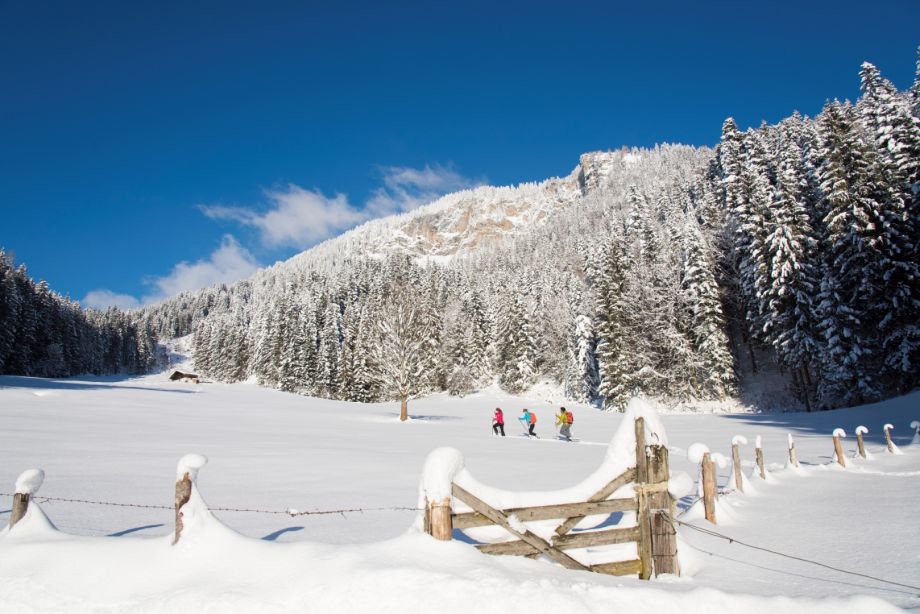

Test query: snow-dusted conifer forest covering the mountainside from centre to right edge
[1,55,920,409]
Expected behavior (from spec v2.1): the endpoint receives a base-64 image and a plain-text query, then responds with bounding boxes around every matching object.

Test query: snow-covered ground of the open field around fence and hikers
[0,375,920,614]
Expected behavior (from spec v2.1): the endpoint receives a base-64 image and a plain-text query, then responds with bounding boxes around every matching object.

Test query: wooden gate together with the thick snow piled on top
[419,399,680,579]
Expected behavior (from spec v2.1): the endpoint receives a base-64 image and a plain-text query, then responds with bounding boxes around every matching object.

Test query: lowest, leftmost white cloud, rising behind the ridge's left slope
[80,235,260,309]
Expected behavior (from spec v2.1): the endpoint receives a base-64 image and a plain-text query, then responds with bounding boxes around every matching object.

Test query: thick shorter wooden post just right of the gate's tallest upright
[637,445,680,576]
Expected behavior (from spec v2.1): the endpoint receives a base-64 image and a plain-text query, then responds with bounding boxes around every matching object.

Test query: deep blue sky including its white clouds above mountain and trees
[0,0,920,305]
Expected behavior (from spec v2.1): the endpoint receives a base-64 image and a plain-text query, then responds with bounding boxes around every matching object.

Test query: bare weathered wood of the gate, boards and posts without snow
[425,418,680,579]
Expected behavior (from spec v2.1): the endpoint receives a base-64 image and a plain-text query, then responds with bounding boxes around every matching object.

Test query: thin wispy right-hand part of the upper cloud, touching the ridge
[365,164,483,217]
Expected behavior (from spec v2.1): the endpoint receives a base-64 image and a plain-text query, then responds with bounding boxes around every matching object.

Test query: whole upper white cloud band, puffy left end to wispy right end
[199,164,482,249]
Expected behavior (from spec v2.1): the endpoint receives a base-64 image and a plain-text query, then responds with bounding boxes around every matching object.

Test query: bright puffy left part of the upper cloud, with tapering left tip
[200,184,367,248]
